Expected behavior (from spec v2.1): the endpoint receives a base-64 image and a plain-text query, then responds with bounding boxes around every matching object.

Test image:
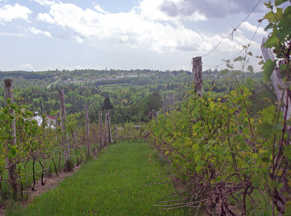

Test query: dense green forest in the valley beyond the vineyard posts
[0,71,272,123]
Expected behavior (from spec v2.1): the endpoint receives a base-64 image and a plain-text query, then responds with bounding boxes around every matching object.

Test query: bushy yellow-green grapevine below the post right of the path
[151,86,280,214]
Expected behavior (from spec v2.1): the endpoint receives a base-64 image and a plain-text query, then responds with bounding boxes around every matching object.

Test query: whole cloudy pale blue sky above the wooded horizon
[0,0,268,71]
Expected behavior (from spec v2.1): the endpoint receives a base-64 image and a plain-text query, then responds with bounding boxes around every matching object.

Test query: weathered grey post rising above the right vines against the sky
[192,57,203,97]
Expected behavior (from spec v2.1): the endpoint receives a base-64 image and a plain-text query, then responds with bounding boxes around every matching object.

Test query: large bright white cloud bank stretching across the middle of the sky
[38,3,226,53]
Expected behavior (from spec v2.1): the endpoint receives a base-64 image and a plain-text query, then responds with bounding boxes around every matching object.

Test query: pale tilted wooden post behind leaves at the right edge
[261,38,291,119]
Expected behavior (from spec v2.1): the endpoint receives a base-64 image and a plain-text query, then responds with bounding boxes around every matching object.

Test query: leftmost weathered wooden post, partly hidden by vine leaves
[4,79,18,199]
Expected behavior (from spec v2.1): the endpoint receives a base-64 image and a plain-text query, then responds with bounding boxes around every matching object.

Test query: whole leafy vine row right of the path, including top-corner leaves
[150,0,291,215]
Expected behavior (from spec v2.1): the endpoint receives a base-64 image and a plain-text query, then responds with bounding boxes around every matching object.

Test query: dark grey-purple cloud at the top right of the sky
[159,0,266,19]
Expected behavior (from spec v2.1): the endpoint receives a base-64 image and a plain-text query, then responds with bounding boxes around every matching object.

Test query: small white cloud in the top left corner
[0,3,32,24]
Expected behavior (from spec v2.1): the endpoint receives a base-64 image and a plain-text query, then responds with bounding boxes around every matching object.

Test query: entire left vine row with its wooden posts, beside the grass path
[0,80,143,204]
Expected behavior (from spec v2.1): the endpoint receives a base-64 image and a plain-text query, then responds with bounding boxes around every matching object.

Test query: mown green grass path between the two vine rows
[7,141,183,216]
